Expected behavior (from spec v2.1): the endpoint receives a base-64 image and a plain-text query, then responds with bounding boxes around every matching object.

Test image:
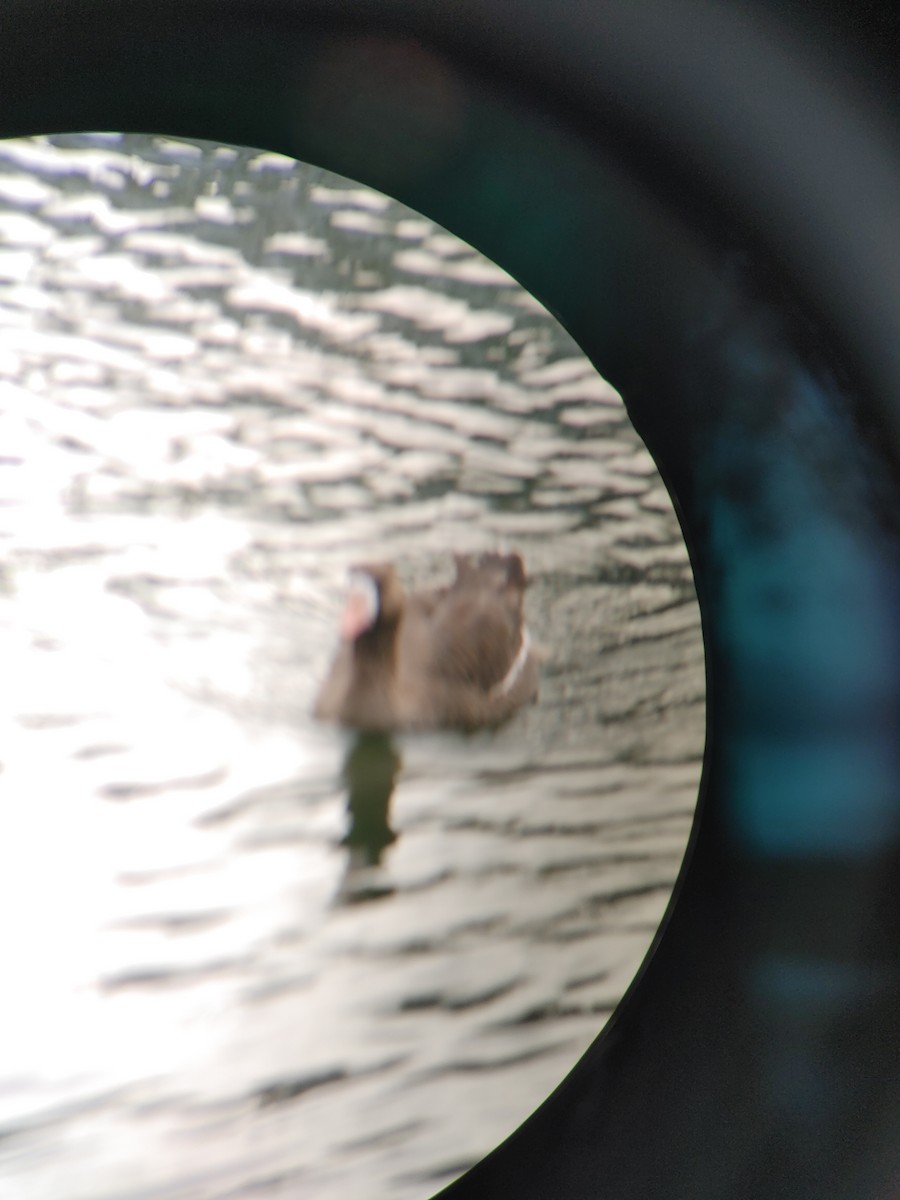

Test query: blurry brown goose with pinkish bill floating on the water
[314,553,538,731]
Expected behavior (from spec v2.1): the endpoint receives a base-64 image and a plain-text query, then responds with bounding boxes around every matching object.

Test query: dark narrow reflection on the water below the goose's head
[342,733,402,899]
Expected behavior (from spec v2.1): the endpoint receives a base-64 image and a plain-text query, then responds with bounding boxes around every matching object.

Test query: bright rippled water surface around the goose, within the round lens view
[0,136,703,1200]
